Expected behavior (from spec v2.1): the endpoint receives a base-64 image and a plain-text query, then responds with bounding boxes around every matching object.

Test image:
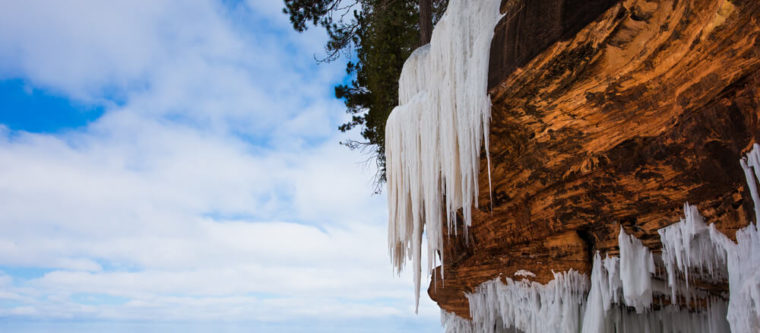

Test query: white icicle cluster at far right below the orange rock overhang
[659,144,760,332]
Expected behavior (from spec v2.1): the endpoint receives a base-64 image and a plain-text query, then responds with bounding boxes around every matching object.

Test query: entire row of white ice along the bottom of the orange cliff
[444,144,760,333]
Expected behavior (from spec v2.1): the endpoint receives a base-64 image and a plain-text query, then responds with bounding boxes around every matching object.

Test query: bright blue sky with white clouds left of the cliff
[0,0,440,332]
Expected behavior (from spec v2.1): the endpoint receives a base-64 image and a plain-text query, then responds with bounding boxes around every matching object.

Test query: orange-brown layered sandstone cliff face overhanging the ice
[428,0,760,318]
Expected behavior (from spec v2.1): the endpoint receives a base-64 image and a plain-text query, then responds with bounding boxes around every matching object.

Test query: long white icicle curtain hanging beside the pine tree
[385,0,501,303]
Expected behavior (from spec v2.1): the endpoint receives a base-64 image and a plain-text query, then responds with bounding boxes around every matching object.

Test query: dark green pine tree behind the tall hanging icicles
[283,0,447,191]
